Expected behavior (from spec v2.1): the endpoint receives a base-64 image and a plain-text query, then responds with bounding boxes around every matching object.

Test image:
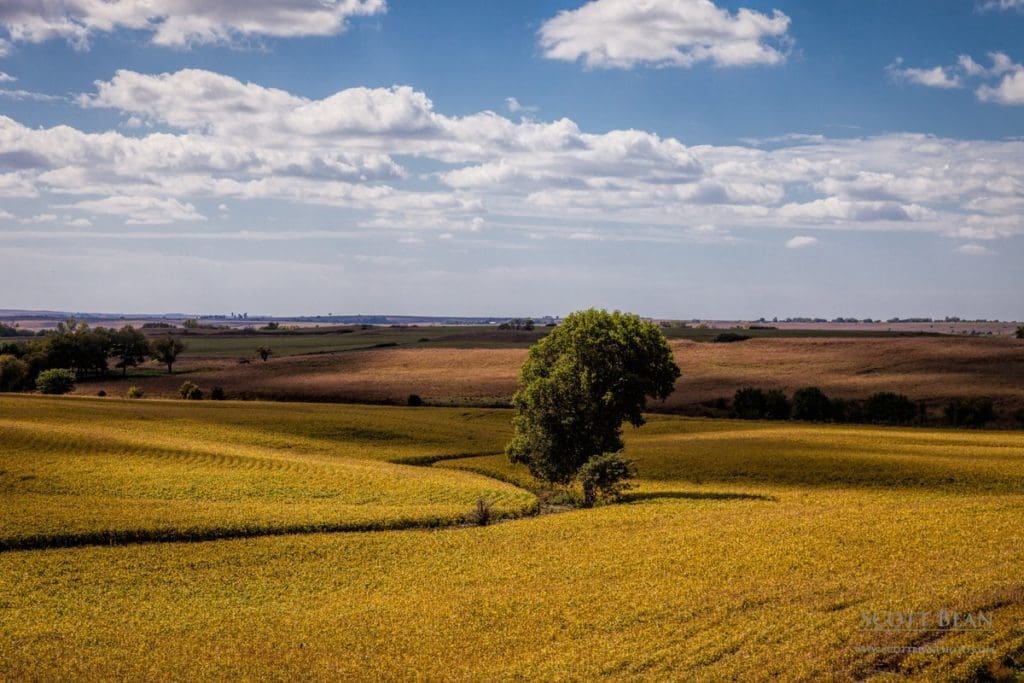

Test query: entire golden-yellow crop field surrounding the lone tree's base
[0,396,1024,680]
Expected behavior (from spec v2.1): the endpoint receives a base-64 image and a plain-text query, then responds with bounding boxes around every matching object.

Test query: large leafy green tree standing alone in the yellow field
[506,308,679,504]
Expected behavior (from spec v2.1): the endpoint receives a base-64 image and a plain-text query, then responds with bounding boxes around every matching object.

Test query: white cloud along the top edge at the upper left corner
[0,0,386,49]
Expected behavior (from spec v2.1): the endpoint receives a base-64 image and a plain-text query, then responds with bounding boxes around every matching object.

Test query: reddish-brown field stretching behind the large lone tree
[78,337,1024,414]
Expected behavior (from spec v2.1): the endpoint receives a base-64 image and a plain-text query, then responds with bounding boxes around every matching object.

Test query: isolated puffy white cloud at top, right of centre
[540,0,791,69]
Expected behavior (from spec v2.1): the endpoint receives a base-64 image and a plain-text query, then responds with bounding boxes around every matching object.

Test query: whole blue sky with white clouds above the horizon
[0,0,1024,319]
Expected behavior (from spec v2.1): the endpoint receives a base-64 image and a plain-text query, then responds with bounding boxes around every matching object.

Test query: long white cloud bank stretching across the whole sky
[0,68,1024,243]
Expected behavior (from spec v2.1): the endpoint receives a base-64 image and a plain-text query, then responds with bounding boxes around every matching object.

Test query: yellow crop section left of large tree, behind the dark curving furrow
[0,397,531,548]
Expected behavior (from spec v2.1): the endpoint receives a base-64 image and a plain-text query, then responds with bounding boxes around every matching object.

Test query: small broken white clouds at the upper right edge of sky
[886,52,1024,105]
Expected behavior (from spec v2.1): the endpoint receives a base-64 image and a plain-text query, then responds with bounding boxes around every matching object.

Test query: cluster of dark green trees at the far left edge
[0,319,185,391]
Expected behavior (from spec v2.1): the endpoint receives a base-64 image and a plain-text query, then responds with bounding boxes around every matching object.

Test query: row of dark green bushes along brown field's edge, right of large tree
[732,387,995,427]
